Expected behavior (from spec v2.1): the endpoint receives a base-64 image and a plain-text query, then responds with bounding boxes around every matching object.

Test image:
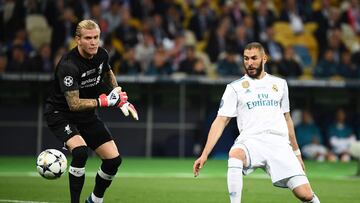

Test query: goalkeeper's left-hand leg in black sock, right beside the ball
[66,135,88,203]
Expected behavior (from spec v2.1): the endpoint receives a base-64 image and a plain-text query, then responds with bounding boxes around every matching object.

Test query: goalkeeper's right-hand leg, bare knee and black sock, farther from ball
[88,140,121,203]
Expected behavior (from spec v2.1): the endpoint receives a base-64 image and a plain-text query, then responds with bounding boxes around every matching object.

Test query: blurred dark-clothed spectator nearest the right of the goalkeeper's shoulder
[119,47,141,75]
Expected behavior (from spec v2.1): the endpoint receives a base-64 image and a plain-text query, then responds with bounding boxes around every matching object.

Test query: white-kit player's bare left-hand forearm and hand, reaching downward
[193,116,231,177]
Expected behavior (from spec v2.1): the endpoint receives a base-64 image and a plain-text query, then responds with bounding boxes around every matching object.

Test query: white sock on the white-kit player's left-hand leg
[227,158,243,203]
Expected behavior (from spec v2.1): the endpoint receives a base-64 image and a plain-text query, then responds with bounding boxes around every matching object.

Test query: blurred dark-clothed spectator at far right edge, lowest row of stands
[339,51,360,79]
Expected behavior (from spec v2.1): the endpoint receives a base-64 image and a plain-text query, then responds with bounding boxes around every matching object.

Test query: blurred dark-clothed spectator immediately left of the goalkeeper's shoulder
[28,43,54,73]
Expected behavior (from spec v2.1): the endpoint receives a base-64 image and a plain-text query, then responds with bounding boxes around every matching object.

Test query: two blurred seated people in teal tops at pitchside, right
[293,108,360,162]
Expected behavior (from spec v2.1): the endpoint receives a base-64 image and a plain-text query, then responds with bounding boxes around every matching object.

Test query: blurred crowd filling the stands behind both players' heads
[0,0,360,79]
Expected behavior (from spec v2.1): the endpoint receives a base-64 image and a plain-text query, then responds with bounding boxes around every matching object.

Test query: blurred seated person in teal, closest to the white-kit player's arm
[295,110,330,161]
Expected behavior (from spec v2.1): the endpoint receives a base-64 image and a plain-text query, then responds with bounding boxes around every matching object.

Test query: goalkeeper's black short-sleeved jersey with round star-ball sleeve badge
[46,47,110,114]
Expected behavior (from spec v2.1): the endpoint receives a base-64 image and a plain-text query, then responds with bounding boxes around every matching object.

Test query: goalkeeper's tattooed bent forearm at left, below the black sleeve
[64,90,97,111]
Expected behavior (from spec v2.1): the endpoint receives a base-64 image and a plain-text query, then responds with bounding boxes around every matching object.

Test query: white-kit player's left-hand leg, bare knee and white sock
[227,148,246,203]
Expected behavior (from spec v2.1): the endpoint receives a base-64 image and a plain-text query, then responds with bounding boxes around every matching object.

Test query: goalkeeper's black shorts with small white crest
[44,110,113,150]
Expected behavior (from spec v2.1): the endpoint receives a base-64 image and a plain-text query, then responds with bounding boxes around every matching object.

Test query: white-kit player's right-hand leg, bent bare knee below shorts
[287,176,320,203]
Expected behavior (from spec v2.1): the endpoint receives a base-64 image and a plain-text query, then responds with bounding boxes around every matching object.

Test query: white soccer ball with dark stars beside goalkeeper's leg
[36,149,67,179]
